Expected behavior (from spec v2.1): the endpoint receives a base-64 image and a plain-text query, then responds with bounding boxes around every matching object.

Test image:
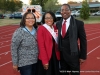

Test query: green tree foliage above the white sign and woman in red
[30,0,59,12]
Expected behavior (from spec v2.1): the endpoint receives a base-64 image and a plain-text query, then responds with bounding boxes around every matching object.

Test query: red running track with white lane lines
[0,24,100,75]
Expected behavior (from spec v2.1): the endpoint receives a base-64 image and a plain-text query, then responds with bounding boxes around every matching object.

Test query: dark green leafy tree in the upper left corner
[0,0,23,13]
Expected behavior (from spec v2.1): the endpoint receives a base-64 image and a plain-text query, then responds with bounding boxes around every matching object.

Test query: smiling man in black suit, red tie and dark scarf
[56,4,87,75]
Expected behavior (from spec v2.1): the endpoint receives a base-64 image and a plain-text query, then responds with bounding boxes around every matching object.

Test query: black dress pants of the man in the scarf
[60,54,80,75]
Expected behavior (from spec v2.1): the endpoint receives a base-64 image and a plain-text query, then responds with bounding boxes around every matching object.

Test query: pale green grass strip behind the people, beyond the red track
[0,16,100,26]
